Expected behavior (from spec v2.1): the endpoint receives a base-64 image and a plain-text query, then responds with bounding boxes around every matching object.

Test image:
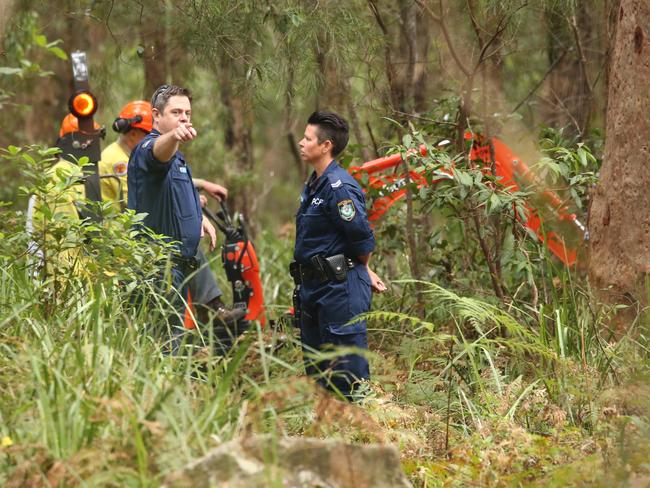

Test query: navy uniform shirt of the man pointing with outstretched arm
[127,129,202,257]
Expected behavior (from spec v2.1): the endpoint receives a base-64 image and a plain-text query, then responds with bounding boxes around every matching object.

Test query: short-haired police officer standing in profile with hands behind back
[290,111,386,399]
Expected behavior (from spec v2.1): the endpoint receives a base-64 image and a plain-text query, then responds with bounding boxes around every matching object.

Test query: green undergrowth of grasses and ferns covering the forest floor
[0,139,650,486]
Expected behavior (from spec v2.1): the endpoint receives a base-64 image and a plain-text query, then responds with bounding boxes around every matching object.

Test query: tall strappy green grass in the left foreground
[0,244,304,485]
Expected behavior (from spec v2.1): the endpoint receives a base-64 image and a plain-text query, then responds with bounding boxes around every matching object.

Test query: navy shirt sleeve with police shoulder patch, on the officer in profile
[327,185,375,257]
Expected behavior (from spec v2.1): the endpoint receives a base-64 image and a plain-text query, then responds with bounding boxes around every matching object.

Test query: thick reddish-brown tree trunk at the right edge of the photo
[589,0,650,304]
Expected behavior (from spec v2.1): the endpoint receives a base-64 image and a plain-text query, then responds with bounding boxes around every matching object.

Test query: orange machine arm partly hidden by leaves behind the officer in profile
[349,132,587,266]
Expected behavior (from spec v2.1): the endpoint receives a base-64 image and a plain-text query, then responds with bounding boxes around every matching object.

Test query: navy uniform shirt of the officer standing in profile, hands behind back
[294,161,375,264]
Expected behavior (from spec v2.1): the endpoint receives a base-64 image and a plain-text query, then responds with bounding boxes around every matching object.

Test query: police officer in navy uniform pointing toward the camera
[127,85,223,352]
